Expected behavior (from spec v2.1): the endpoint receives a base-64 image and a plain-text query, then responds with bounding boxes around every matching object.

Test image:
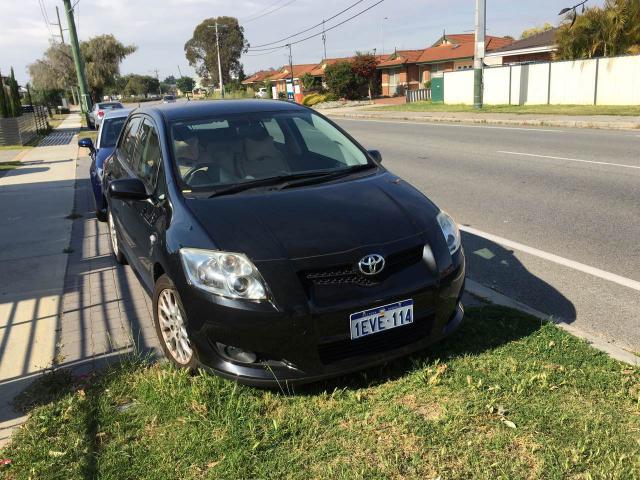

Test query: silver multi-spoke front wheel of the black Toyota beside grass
[153,275,198,370]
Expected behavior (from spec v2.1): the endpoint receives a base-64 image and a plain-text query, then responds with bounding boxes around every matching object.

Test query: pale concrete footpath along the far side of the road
[318,105,640,130]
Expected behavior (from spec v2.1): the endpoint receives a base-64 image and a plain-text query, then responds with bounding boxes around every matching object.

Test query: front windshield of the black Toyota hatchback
[170,111,373,190]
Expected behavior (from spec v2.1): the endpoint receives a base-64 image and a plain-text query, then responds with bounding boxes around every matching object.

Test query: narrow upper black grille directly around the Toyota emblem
[302,245,424,287]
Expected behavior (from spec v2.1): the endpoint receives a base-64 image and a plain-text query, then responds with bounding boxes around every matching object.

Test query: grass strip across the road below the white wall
[375,102,640,116]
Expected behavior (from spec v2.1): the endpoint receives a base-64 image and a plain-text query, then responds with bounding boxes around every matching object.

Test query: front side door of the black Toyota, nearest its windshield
[127,117,164,281]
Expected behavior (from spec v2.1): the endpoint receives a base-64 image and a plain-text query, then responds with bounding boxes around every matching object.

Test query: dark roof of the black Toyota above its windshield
[136,100,306,121]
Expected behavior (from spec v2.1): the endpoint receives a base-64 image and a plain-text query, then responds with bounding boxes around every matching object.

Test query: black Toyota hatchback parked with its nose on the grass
[103,100,465,386]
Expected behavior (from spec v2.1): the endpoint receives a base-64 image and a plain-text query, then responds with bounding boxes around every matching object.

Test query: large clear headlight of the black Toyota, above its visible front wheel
[180,248,267,300]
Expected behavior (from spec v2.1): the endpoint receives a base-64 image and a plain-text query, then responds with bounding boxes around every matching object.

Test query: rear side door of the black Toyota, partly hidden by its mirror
[105,116,142,267]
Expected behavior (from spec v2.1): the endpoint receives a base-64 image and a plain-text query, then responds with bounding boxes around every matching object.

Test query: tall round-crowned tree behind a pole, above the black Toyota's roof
[181,17,249,86]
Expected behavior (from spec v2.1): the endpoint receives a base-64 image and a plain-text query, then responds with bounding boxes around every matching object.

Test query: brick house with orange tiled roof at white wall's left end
[378,34,512,96]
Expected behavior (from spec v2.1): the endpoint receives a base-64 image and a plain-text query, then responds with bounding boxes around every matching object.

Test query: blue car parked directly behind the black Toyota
[78,108,132,222]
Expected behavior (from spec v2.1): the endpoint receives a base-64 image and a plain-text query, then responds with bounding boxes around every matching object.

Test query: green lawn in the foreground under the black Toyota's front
[0,307,640,480]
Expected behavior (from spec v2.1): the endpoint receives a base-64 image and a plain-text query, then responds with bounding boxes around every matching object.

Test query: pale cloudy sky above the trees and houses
[0,0,603,84]
